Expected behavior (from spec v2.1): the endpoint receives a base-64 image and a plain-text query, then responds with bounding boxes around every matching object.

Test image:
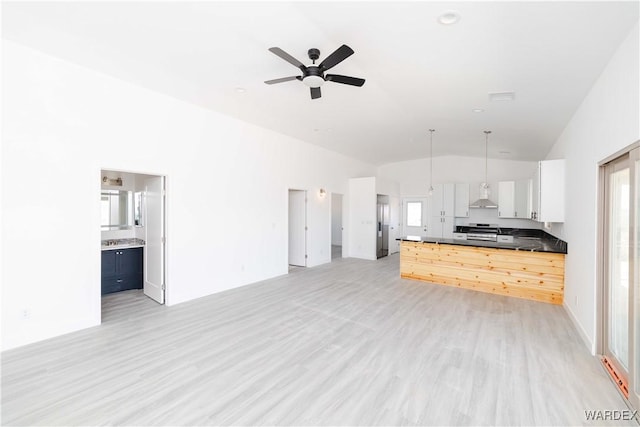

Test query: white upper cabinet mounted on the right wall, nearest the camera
[531,159,565,222]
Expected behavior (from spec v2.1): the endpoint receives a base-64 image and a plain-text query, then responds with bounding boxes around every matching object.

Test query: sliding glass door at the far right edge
[599,144,640,409]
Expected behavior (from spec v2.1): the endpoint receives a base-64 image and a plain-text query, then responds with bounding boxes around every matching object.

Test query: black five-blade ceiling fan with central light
[265,44,364,99]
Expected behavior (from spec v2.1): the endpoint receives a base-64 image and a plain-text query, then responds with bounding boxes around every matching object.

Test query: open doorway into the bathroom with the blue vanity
[100,169,166,318]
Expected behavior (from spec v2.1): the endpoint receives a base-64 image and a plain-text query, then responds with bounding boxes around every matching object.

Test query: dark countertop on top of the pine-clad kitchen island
[396,229,567,254]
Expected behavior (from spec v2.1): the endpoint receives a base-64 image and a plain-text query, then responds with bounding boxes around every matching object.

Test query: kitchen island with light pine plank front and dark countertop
[399,233,567,304]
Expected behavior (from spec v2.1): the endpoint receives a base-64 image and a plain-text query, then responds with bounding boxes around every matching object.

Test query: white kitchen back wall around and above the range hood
[378,156,541,228]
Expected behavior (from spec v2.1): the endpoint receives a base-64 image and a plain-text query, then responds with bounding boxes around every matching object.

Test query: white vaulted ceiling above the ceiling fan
[2,1,639,164]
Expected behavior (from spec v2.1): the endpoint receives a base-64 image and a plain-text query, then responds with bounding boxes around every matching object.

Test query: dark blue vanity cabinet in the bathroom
[102,248,143,295]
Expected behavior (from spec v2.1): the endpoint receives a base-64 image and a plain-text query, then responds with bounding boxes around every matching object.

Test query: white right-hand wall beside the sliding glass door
[547,21,640,352]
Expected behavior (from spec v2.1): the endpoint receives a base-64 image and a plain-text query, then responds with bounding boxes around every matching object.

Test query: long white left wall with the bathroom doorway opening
[2,40,375,349]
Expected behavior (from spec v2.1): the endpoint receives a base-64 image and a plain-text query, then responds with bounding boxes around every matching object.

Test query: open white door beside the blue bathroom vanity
[144,177,165,304]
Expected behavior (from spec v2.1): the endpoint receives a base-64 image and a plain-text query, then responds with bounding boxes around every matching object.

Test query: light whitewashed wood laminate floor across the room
[2,254,627,425]
